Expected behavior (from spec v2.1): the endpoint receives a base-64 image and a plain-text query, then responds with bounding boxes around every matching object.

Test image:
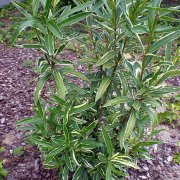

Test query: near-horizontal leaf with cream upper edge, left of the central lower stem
[70,101,95,114]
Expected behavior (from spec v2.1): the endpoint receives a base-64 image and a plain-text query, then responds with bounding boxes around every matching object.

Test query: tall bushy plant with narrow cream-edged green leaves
[12,0,180,180]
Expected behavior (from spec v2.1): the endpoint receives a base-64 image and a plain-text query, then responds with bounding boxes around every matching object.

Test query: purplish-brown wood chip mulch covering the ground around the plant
[0,45,180,180]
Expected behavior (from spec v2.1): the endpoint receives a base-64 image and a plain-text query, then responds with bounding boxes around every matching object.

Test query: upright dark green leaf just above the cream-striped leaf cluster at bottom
[102,128,113,157]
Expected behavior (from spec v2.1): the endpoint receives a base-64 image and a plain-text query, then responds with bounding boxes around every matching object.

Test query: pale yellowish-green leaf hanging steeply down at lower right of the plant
[124,111,136,140]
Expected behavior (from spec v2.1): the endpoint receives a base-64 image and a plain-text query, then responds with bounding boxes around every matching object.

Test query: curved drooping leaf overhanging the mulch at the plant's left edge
[34,72,51,103]
